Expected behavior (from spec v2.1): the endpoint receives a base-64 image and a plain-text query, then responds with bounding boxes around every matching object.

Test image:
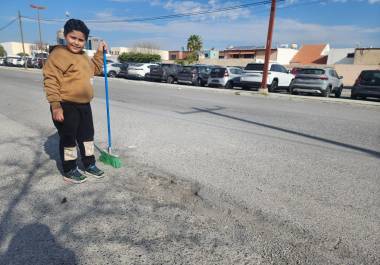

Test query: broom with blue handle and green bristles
[95,49,121,168]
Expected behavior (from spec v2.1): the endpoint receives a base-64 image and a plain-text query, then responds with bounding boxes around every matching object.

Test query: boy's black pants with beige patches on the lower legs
[53,102,95,173]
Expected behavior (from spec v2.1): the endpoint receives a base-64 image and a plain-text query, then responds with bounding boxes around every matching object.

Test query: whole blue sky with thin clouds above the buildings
[0,0,380,50]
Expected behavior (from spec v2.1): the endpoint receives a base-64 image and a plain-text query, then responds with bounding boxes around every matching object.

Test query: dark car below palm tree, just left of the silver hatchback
[178,65,214,86]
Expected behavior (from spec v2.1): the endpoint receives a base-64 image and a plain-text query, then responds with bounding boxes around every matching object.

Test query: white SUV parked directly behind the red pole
[240,63,294,92]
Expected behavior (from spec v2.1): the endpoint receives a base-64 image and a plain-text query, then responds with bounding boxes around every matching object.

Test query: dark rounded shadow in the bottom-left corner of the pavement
[0,223,77,265]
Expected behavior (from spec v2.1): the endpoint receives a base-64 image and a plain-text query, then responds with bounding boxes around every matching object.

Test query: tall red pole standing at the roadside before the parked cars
[259,0,276,94]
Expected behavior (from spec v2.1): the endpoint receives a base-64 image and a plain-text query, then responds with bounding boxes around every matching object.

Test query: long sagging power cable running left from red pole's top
[19,0,285,23]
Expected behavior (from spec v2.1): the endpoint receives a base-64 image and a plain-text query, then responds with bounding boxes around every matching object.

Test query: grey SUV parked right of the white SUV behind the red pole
[290,67,343,98]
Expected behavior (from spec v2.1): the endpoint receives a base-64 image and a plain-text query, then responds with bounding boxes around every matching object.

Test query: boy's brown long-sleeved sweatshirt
[43,46,103,109]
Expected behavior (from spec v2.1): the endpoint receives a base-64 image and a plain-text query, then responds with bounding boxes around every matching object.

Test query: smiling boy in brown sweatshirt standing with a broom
[43,19,107,184]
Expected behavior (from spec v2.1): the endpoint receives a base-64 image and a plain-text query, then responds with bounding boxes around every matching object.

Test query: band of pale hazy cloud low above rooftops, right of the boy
[89,11,380,49]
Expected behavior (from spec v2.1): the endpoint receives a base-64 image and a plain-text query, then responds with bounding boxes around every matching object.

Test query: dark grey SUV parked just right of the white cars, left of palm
[146,63,182,84]
